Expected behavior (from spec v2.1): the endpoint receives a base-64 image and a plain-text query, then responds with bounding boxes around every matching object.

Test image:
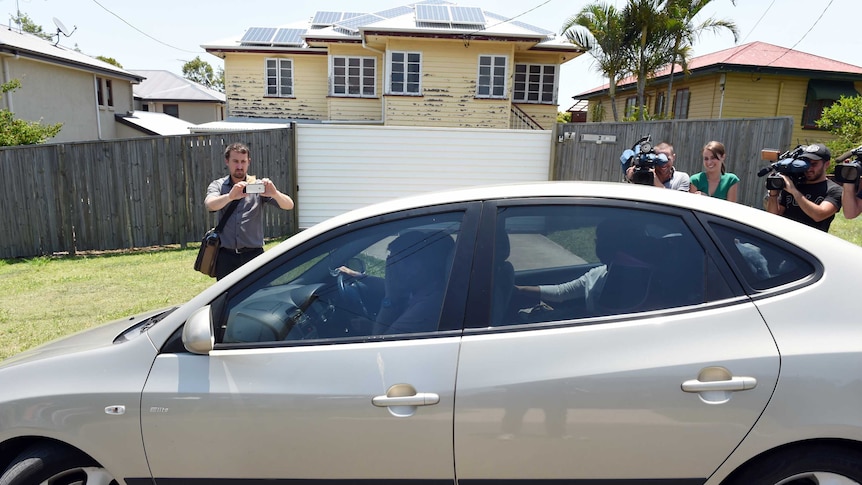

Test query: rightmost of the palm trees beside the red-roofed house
[662,0,739,117]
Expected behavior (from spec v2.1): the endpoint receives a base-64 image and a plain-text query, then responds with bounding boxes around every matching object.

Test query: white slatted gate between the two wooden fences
[296,124,552,228]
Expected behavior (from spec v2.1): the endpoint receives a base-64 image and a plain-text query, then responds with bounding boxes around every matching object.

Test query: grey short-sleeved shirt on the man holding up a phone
[207,175,278,249]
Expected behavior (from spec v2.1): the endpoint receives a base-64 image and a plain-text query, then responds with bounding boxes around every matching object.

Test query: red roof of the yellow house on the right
[573,42,862,99]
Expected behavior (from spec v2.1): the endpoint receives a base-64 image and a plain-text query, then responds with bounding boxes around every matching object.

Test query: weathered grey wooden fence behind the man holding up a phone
[0,128,297,258]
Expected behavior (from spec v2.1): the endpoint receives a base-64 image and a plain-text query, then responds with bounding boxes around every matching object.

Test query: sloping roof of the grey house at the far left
[0,25,143,83]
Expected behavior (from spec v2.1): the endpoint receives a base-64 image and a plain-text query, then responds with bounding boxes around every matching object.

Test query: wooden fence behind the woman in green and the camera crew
[551,117,793,208]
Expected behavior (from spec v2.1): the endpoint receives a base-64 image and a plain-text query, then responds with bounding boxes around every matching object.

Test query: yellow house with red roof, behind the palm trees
[573,42,862,144]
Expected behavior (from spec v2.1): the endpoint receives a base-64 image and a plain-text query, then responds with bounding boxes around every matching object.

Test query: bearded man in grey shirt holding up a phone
[204,143,293,280]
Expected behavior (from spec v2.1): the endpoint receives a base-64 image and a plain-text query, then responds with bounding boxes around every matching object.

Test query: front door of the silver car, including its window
[141,206,478,484]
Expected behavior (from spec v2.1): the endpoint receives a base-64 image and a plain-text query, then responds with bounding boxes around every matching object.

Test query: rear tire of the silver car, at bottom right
[728,444,862,485]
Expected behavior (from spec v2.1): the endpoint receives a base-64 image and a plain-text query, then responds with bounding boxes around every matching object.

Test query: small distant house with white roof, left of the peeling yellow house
[129,69,225,125]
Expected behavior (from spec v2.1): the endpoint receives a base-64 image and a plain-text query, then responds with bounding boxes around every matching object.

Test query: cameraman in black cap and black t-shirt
[766,143,841,232]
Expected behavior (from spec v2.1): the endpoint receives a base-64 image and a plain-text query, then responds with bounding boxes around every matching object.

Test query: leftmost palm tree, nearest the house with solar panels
[562,2,630,121]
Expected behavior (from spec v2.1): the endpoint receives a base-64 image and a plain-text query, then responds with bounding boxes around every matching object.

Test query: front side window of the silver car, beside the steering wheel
[218,212,470,344]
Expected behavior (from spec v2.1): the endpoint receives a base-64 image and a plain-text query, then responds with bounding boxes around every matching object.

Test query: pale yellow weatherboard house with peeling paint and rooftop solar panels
[202,0,582,129]
